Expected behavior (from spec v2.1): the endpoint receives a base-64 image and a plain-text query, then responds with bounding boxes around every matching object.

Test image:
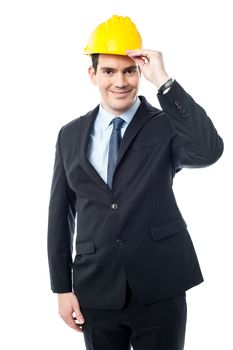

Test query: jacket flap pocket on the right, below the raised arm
[150,218,187,241]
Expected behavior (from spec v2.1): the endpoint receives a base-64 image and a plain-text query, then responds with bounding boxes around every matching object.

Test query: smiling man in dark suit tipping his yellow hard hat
[48,16,223,350]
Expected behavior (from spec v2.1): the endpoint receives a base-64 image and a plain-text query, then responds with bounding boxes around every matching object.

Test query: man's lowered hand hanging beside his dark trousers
[58,293,85,333]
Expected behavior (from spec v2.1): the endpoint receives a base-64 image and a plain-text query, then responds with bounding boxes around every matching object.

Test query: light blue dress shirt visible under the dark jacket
[87,97,141,183]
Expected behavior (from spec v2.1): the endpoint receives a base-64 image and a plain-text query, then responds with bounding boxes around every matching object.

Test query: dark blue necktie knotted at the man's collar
[107,117,124,188]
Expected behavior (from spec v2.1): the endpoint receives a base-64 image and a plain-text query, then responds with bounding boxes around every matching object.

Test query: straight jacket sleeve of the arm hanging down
[47,129,76,293]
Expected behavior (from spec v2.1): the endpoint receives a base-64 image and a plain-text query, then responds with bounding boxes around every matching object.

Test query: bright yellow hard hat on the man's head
[84,15,142,56]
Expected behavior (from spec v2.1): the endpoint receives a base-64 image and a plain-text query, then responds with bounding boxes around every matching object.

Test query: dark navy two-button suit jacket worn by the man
[48,81,223,309]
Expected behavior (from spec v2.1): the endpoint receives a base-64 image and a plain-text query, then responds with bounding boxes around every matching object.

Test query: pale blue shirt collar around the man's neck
[96,97,141,130]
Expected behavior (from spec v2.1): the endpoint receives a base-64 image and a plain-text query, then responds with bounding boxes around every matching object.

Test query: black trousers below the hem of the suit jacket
[81,285,187,350]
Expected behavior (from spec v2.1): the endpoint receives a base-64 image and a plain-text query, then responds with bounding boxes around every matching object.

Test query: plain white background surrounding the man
[0,0,233,350]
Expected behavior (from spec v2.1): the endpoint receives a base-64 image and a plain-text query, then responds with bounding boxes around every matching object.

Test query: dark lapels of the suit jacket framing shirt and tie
[80,96,161,191]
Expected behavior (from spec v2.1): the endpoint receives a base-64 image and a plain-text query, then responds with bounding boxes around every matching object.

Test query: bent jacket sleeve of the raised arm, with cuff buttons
[157,80,223,171]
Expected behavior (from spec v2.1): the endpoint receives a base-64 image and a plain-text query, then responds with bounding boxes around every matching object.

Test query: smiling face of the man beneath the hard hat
[89,54,140,115]
